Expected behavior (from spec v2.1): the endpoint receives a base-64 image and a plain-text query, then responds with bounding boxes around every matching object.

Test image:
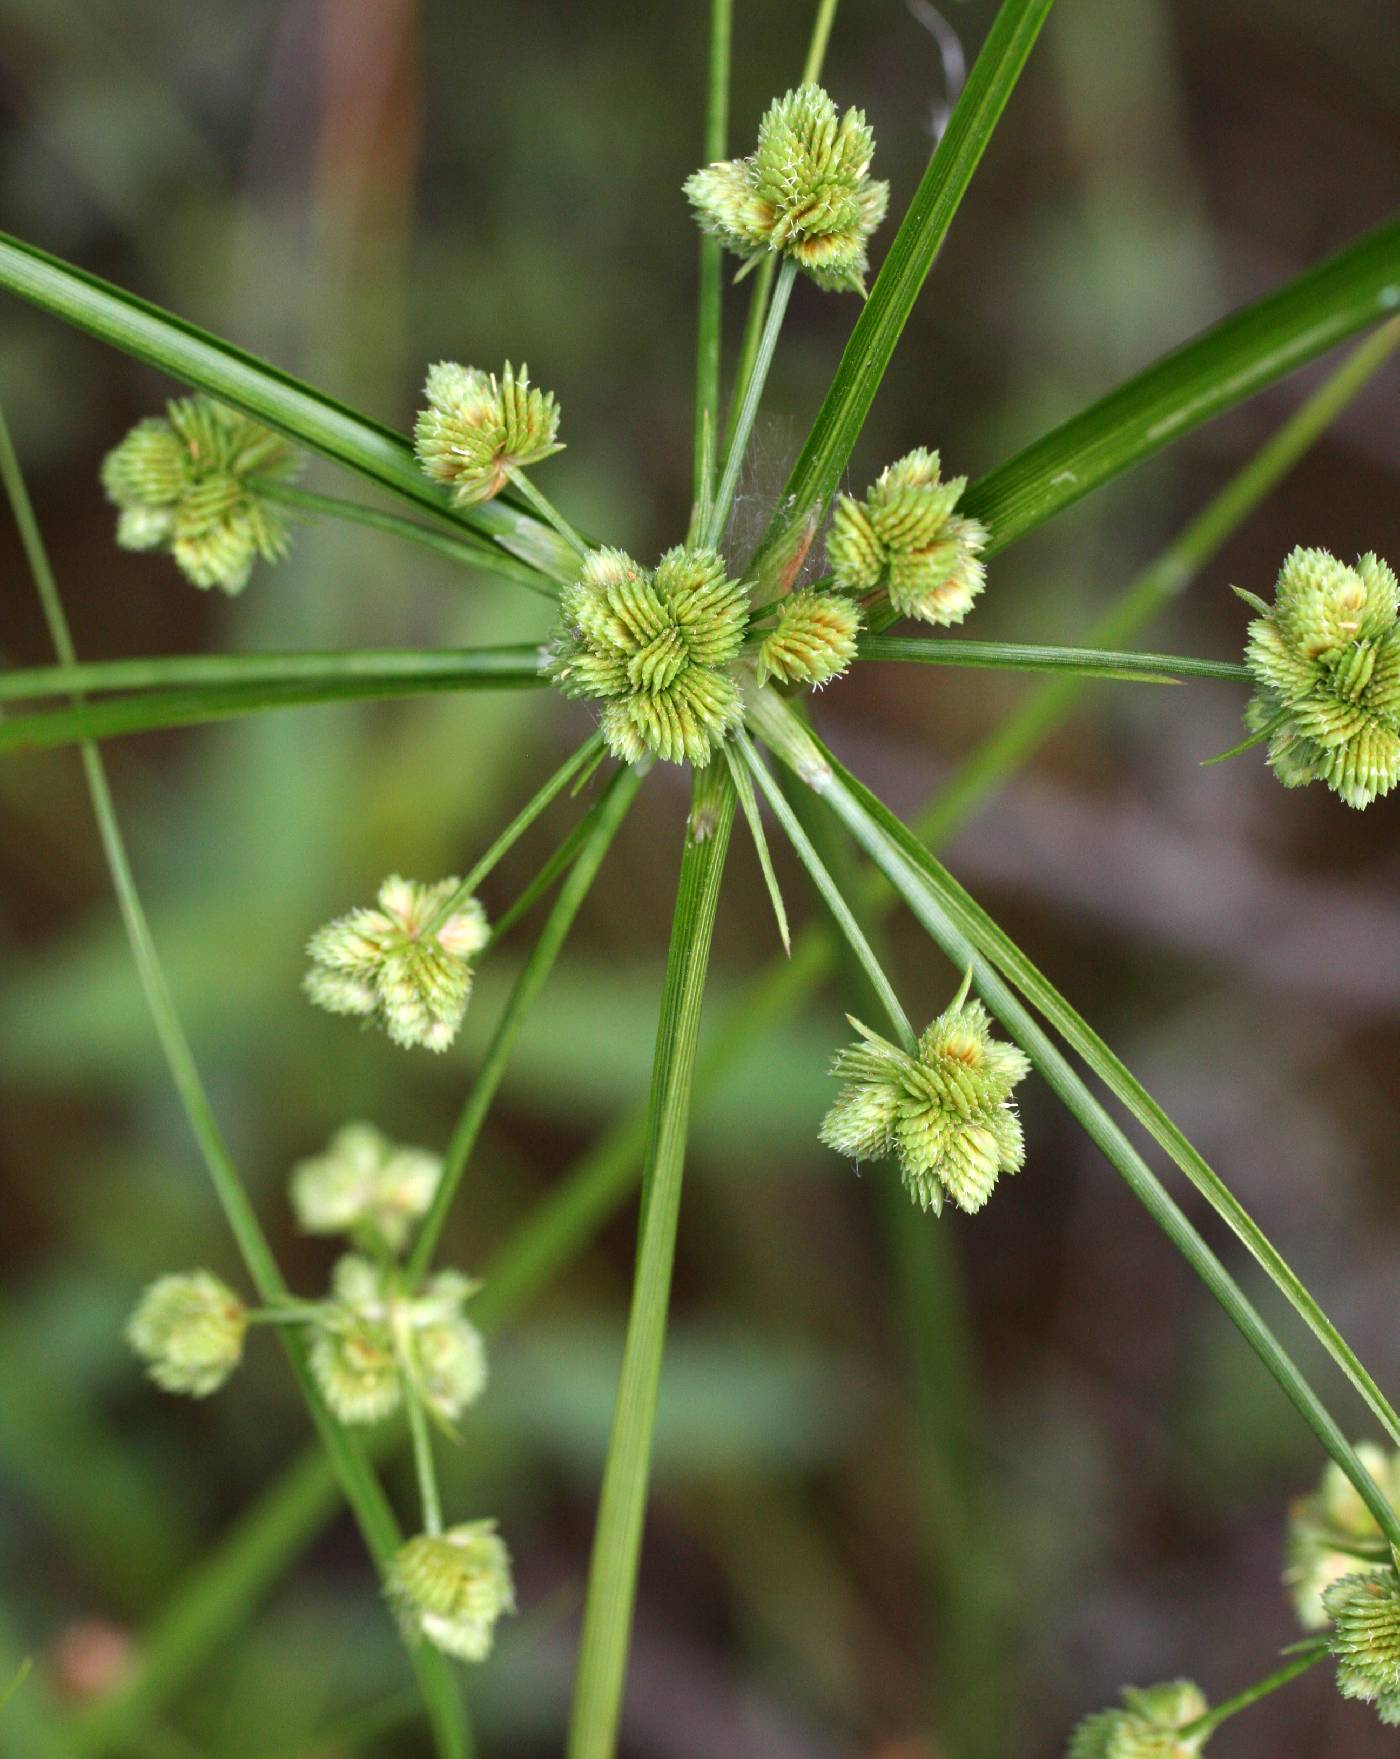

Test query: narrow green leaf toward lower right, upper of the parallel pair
[759,693,1400,1444]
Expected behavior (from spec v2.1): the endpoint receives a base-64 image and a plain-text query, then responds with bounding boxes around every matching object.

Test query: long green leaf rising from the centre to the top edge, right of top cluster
[763,0,1052,552]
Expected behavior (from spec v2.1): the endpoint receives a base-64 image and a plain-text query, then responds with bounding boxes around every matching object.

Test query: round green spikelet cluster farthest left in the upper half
[102,398,297,593]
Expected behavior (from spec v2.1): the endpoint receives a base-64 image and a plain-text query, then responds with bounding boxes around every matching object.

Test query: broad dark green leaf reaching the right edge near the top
[960,222,1400,556]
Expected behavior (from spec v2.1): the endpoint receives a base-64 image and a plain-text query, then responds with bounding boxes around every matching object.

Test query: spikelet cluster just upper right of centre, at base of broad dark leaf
[827,447,987,626]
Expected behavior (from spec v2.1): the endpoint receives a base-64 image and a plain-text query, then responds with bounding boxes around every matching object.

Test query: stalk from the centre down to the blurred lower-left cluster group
[405,769,642,1289]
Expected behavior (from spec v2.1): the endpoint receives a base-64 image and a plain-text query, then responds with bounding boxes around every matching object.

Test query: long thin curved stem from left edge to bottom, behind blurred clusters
[0,399,471,1759]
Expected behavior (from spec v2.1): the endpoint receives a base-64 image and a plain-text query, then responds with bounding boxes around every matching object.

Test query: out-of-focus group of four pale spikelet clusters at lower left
[127,1124,515,1660]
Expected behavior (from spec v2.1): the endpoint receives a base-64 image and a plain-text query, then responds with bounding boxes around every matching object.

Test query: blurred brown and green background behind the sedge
[0,0,1400,1759]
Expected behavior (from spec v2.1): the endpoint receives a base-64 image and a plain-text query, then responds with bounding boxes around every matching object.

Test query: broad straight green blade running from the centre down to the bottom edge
[566,765,735,1759]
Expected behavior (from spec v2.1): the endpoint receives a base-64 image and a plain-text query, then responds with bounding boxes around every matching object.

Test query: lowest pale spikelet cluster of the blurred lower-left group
[385,1522,515,1660]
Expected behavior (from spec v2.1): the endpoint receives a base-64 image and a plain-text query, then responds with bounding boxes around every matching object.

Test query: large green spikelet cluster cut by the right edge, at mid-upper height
[1245,549,1400,807]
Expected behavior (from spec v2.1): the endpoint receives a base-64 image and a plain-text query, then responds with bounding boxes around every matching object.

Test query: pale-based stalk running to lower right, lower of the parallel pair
[758,697,1400,1544]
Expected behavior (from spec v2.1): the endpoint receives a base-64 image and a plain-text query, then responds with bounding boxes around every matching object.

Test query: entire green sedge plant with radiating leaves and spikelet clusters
[0,0,1400,1759]
